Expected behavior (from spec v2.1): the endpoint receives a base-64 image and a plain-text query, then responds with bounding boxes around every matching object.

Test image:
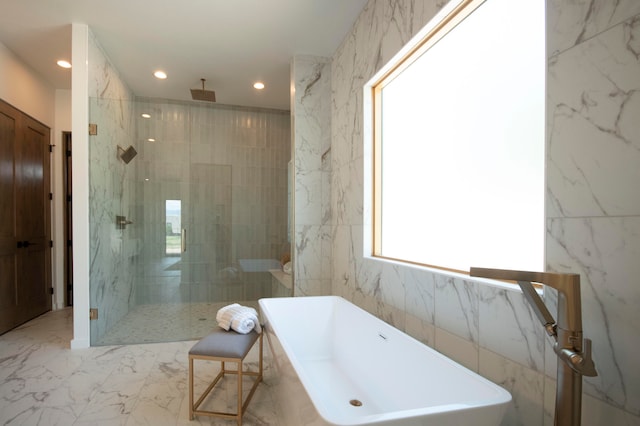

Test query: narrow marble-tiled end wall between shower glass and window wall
[291,55,332,296]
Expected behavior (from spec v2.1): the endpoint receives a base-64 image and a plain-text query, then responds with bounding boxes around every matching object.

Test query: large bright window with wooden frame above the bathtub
[365,0,546,272]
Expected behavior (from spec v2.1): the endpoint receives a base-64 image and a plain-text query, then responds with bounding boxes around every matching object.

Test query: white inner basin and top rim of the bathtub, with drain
[261,296,510,424]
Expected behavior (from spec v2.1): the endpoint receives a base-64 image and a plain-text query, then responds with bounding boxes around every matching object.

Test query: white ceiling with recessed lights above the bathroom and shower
[0,0,367,110]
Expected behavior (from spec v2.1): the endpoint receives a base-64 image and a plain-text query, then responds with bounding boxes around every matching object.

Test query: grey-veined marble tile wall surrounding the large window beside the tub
[320,0,640,425]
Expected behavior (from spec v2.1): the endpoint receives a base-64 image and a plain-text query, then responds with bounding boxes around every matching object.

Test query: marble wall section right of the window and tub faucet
[547,0,640,424]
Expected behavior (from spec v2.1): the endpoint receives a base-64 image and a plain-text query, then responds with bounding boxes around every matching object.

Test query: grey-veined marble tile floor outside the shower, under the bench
[0,309,278,426]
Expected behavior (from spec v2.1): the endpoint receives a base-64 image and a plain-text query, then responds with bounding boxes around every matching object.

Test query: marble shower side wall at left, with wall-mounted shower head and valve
[89,32,136,342]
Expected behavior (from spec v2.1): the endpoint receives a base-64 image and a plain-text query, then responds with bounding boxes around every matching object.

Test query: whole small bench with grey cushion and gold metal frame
[189,328,262,426]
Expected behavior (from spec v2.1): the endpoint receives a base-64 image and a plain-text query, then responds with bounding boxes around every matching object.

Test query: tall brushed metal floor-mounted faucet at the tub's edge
[470,268,598,426]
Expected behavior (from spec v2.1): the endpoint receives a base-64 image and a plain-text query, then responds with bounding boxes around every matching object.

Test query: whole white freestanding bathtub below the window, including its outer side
[260,296,511,426]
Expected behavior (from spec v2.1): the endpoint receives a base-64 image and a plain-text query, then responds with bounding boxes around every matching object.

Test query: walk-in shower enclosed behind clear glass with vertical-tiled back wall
[90,98,291,345]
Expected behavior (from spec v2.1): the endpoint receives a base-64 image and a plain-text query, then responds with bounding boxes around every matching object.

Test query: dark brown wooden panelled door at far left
[0,101,51,333]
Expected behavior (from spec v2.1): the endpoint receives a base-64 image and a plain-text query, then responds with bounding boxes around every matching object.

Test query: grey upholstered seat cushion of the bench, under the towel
[189,328,260,359]
